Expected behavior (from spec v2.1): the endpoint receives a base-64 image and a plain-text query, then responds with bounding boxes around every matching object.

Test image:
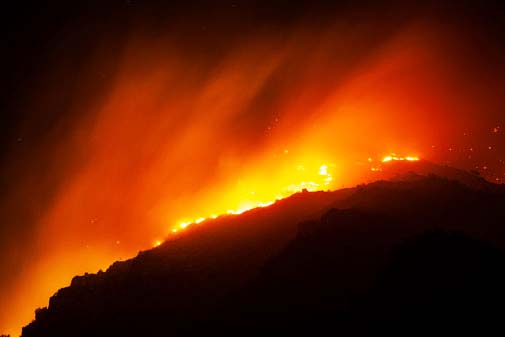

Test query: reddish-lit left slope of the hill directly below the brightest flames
[23,190,353,336]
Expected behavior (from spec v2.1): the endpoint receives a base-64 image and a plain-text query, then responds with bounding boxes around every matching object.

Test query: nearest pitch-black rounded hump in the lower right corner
[365,230,505,336]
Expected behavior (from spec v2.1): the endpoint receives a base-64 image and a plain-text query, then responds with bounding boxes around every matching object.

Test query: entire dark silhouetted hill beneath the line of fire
[23,164,505,337]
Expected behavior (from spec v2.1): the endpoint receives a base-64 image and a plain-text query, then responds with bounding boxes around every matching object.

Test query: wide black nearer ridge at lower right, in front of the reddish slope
[235,227,505,336]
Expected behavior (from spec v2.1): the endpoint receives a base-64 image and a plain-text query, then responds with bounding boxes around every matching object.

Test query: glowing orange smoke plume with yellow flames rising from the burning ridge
[0,12,504,334]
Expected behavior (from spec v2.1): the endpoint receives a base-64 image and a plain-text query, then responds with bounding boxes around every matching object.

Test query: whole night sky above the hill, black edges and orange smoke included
[0,0,505,334]
